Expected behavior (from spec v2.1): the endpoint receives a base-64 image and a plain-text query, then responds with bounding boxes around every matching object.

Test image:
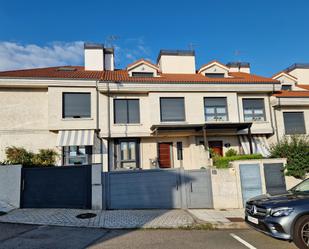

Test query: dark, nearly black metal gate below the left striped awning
[21,165,91,209]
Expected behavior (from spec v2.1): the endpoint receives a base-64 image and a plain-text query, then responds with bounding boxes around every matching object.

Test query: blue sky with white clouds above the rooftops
[0,0,309,76]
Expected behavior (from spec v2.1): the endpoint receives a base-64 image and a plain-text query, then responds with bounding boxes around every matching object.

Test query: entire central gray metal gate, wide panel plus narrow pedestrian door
[103,169,213,209]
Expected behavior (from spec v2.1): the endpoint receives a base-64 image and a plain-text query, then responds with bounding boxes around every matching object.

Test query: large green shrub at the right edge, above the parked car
[270,135,309,179]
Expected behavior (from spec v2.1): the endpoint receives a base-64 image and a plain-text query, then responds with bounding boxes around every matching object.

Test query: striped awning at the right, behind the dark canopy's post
[240,135,270,157]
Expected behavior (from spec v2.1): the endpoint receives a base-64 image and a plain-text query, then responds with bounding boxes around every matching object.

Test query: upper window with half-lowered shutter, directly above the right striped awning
[242,99,265,121]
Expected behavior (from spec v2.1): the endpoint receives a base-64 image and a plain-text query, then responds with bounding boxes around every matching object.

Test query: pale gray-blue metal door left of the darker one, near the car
[239,164,262,206]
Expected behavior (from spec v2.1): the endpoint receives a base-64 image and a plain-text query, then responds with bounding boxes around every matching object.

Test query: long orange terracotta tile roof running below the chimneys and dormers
[0,66,279,84]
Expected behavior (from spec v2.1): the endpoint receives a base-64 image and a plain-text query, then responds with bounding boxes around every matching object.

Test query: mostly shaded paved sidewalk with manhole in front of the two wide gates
[0,209,195,229]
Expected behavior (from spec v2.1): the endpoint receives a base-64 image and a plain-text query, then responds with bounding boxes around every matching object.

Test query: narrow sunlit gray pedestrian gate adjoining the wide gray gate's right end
[186,170,213,208]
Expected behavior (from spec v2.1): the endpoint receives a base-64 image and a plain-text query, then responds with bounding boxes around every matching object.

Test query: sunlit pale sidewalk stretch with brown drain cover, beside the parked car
[188,209,246,228]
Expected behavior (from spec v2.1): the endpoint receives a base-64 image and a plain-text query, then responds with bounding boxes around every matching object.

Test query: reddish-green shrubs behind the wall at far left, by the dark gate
[5,146,58,167]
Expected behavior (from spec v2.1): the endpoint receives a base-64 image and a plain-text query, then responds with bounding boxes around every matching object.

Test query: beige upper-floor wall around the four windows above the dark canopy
[100,92,273,137]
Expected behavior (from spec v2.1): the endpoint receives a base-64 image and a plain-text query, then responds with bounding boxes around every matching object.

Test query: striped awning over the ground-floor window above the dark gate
[57,130,94,146]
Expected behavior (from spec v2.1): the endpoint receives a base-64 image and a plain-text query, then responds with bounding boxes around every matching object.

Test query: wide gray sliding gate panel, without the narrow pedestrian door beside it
[104,170,181,209]
